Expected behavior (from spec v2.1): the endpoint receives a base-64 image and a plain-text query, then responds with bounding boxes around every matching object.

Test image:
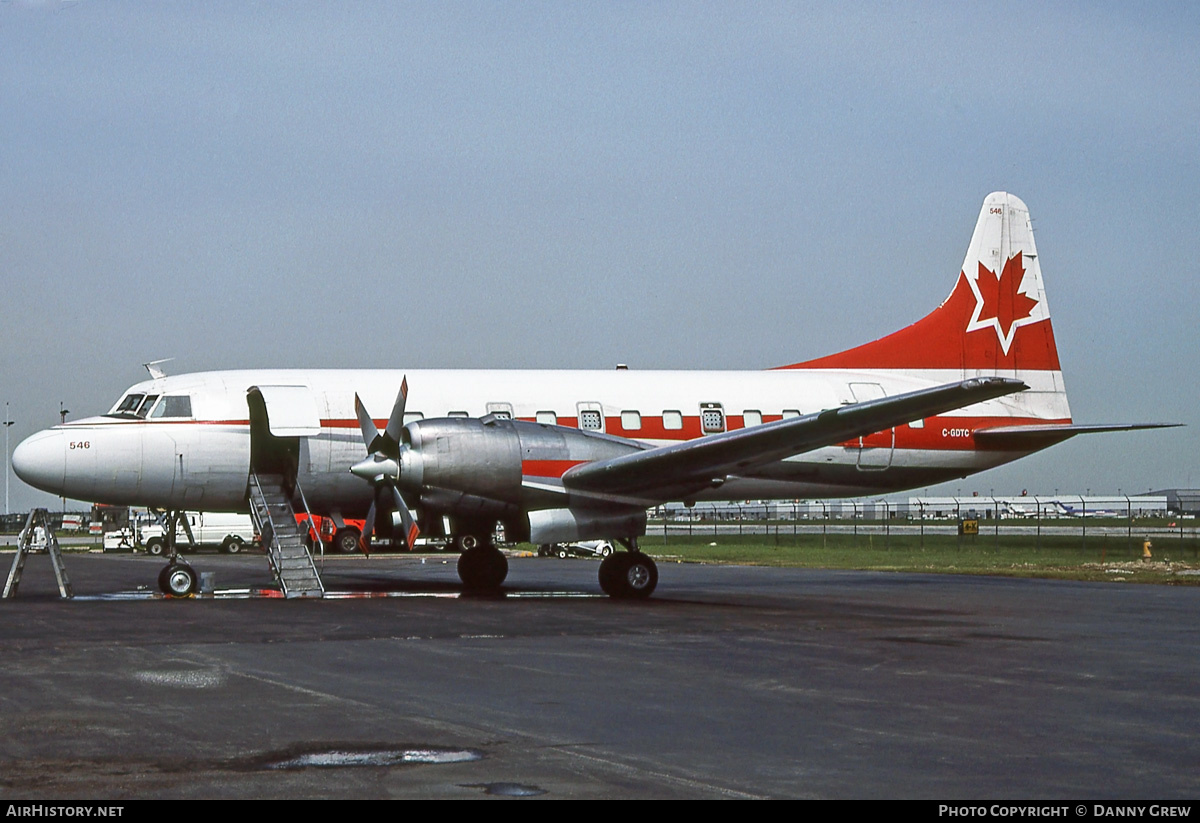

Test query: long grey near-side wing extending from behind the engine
[563,377,1028,499]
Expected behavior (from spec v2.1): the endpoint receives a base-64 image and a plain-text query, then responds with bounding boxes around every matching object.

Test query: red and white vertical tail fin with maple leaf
[784,192,1070,419]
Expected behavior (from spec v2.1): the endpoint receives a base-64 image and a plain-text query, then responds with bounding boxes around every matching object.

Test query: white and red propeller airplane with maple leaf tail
[13,192,1171,596]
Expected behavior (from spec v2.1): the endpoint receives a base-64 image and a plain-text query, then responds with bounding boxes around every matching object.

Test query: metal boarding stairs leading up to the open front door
[250,473,325,599]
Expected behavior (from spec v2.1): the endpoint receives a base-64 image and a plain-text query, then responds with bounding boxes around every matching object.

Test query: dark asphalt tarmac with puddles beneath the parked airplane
[0,554,1200,800]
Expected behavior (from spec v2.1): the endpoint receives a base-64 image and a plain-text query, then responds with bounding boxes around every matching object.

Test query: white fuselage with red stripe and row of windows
[13,370,1069,516]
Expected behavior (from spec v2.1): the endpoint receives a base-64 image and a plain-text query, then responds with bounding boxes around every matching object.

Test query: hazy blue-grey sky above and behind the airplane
[0,0,1200,509]
